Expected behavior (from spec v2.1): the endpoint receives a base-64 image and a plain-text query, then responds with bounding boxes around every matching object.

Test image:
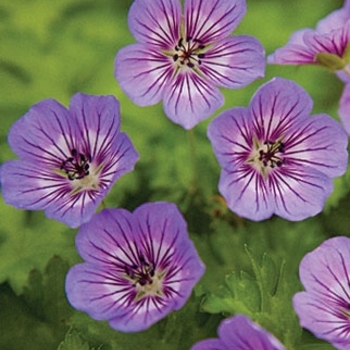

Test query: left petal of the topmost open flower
[114,44,173,106]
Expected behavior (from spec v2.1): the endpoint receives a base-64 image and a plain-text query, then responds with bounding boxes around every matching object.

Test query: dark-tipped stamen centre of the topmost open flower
[173,37,205,68]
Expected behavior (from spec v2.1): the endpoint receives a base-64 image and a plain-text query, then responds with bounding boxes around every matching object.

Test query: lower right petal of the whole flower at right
[269,166,333,221]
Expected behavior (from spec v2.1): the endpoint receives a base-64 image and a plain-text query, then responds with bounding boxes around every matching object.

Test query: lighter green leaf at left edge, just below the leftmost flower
[0,200,80,294]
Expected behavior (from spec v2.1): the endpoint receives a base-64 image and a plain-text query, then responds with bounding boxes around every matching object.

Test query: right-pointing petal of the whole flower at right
[283,114,348,177]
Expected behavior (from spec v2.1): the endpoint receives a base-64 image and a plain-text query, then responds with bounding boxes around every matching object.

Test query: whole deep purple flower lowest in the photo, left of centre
[66,203,205,332]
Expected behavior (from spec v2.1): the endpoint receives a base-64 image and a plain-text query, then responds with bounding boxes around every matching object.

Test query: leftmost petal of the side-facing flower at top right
[267,29,317,64]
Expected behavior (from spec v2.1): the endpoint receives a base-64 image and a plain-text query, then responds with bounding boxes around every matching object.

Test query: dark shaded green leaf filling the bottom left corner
[0,256,72,350]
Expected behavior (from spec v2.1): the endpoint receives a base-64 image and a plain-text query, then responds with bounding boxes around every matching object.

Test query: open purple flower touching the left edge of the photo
[1,93,138,227]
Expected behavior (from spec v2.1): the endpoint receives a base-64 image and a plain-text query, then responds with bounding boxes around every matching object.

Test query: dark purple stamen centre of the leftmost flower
[61,149,91,180]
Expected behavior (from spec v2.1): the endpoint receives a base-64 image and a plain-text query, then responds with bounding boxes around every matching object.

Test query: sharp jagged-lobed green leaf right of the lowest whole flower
[202,247,301,349]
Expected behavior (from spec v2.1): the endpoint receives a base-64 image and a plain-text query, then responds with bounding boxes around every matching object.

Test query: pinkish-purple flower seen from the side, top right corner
[268,0,350,76]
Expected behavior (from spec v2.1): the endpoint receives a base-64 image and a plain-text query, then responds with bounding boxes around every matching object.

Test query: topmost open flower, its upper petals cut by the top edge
[115,0,265,129]
